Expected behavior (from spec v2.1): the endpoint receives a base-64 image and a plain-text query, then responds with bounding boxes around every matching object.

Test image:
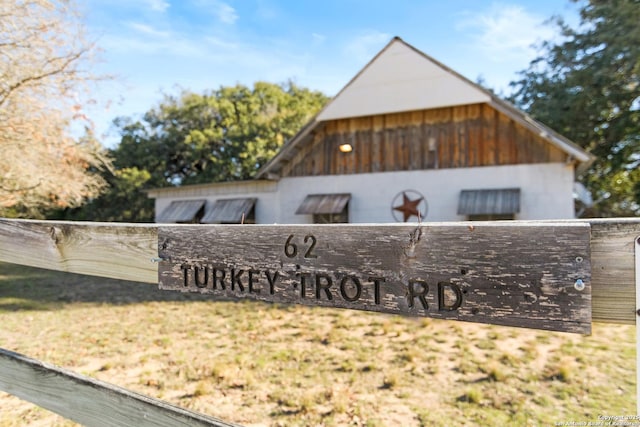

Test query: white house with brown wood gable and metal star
[149,38,592,224]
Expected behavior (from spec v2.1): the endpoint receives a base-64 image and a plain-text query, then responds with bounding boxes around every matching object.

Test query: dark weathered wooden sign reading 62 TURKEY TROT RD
[158,222,591,334]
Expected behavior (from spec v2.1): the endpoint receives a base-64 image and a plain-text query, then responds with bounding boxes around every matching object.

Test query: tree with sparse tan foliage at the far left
[0,0,108,215]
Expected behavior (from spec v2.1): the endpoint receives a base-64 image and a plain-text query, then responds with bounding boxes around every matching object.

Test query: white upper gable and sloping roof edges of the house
[256,37,593,178]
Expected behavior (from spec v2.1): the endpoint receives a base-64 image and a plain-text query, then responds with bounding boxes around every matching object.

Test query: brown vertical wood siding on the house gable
[280,104,568,177]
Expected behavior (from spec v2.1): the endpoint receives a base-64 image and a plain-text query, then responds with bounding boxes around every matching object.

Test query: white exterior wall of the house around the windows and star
[150,163,574,224]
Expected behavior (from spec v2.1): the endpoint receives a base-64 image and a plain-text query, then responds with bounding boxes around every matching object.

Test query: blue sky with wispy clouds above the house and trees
[81,0,578,145]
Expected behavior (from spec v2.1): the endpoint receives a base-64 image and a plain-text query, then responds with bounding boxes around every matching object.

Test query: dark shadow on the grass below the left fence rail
[0,263,211,312]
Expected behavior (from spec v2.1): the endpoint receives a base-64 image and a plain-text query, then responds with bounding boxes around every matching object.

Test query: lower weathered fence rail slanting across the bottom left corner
[0,349,238,427]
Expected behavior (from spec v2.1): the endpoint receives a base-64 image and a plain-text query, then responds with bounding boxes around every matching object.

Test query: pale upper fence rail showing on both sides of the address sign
[0,218,640,324]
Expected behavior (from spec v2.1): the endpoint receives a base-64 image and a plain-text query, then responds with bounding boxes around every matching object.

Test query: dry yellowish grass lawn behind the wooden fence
[0,264,636,426]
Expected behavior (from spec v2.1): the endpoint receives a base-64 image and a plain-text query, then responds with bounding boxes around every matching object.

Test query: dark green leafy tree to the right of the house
[511,0,640,216]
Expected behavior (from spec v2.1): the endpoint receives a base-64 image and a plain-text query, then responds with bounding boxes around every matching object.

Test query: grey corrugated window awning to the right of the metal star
[458,188,520,215]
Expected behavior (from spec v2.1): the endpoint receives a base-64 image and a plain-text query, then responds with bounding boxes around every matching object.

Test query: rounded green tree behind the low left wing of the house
[59,82,327,221]
